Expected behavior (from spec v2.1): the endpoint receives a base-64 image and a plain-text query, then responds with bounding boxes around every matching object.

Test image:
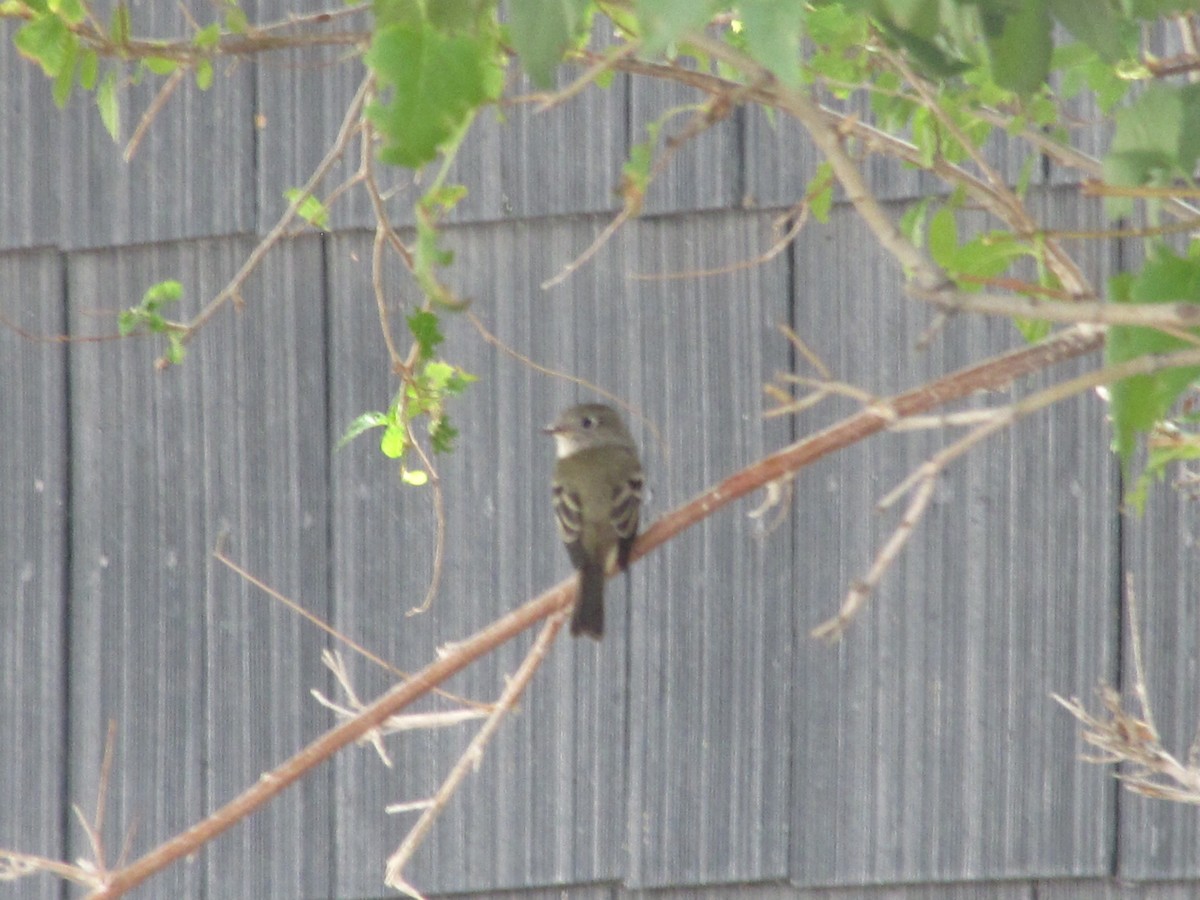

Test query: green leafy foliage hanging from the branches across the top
[9,0,1200,504]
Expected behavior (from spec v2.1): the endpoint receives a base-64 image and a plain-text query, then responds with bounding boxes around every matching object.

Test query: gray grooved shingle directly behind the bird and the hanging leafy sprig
[331,220,625,894]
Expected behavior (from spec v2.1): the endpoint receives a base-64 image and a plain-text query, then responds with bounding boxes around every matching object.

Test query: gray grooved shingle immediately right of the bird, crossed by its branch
[614,212,794,887]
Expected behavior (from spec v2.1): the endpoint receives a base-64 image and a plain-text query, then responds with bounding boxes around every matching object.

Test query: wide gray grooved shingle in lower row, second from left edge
[68,239,332,896]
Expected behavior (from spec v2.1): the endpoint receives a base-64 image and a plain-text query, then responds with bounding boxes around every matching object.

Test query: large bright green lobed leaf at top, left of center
[365,23,503,168]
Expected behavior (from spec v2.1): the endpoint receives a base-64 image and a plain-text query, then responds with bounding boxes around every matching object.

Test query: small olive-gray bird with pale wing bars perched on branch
[544,403,642,641]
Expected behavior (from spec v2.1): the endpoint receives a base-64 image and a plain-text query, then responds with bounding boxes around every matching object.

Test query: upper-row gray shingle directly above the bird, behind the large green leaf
[257,0,628,229]
